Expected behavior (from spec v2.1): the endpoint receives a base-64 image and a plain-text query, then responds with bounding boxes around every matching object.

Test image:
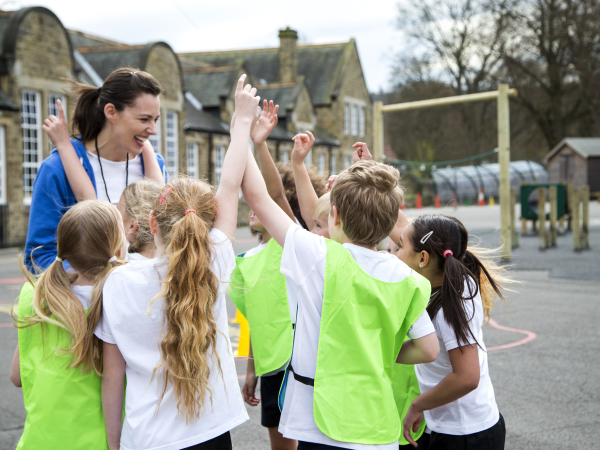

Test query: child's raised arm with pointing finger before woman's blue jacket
[42,100,96,202]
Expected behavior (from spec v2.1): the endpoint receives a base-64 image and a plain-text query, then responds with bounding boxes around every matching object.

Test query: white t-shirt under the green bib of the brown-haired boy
[279,226,434,450]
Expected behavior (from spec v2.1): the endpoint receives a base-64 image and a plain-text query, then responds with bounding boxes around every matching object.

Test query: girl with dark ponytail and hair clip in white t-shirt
[397,215,509,450]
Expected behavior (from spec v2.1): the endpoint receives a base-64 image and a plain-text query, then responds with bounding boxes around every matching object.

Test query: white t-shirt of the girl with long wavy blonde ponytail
[95,229,248,450]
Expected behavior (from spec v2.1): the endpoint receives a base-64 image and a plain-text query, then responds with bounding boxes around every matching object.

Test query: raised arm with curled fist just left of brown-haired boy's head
[292,131,319,230]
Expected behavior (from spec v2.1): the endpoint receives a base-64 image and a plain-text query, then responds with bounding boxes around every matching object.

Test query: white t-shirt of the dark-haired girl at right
[415,279,500,435]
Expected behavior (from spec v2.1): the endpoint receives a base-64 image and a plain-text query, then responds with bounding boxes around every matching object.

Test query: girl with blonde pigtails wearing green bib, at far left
[11,200,124,450]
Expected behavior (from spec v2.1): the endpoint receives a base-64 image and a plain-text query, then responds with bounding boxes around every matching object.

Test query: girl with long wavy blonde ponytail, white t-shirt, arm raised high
[95,75,259,449]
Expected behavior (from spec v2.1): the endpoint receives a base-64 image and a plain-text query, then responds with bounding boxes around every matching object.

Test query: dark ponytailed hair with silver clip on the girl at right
[410,215,503,347]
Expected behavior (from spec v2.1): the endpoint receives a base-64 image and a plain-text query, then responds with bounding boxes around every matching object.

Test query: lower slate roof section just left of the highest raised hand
[183,64,240,108]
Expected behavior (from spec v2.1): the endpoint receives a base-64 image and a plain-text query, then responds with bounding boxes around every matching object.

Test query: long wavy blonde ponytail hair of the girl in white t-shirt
[152,178,222,423]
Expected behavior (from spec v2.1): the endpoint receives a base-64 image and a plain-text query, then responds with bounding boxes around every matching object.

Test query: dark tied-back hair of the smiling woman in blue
[70,67,162,142]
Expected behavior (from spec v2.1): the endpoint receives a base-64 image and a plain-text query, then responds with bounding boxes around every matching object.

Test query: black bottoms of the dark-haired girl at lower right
[428,414,506,450]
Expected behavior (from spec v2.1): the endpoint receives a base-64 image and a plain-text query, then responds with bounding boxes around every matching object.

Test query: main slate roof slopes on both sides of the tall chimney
[180,39,355,106]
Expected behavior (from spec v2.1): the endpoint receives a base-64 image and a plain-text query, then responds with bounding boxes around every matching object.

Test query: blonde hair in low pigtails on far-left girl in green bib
[16,200,124,372]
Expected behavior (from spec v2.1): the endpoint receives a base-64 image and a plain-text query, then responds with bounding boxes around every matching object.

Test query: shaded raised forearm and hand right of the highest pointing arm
[250,100,294,219]
